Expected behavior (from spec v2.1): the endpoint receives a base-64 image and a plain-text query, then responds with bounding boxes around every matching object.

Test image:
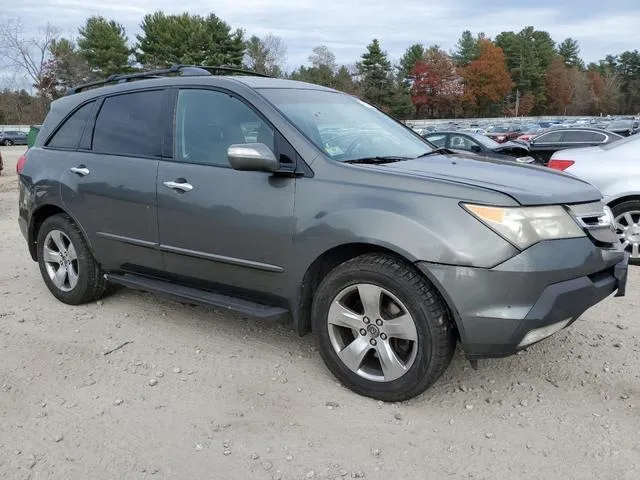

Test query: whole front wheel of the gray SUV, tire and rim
[311,253,456,402]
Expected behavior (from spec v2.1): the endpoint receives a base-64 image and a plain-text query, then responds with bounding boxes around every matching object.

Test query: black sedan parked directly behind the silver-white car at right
[529,127,622,165]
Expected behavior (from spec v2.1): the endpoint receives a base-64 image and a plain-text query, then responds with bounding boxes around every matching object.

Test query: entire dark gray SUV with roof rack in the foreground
[18,66,627,401]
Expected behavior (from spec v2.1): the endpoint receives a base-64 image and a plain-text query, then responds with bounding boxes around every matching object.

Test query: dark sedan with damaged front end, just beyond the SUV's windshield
[424,131,535,163]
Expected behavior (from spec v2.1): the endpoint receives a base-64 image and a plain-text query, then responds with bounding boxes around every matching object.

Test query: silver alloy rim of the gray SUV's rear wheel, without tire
[42,230,79,292]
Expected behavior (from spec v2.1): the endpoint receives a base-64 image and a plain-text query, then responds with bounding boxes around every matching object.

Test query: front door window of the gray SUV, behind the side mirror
[176,90,275,166]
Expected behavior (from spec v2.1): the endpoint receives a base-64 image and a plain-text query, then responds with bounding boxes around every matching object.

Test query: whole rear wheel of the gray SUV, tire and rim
[37,214,107,305]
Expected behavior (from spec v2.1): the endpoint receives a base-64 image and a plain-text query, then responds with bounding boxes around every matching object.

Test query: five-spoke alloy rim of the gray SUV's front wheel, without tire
[327,283,418,382]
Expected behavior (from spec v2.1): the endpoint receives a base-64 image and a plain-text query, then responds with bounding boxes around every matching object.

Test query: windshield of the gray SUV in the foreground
[255,88,433,162]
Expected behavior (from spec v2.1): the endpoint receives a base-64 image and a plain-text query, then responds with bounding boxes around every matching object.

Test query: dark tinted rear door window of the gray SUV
[93,90,167,157]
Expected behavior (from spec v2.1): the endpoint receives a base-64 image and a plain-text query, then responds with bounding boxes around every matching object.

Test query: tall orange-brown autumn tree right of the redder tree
[459,39,513,115]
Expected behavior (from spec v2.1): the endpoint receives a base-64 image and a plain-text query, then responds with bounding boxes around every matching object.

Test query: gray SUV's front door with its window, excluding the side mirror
[157,89,295,295]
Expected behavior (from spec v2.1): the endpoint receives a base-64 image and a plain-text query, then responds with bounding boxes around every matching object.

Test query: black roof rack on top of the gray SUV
[66,65,269,95]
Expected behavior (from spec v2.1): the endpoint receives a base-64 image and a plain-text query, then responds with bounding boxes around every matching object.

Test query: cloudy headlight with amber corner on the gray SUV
[463,203,585,250]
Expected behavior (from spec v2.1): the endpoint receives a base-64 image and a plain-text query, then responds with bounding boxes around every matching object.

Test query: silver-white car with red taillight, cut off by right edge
[548,134,640,264]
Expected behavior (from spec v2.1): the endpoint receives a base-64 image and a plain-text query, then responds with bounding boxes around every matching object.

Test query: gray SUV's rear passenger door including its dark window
[54,89,171,273]
